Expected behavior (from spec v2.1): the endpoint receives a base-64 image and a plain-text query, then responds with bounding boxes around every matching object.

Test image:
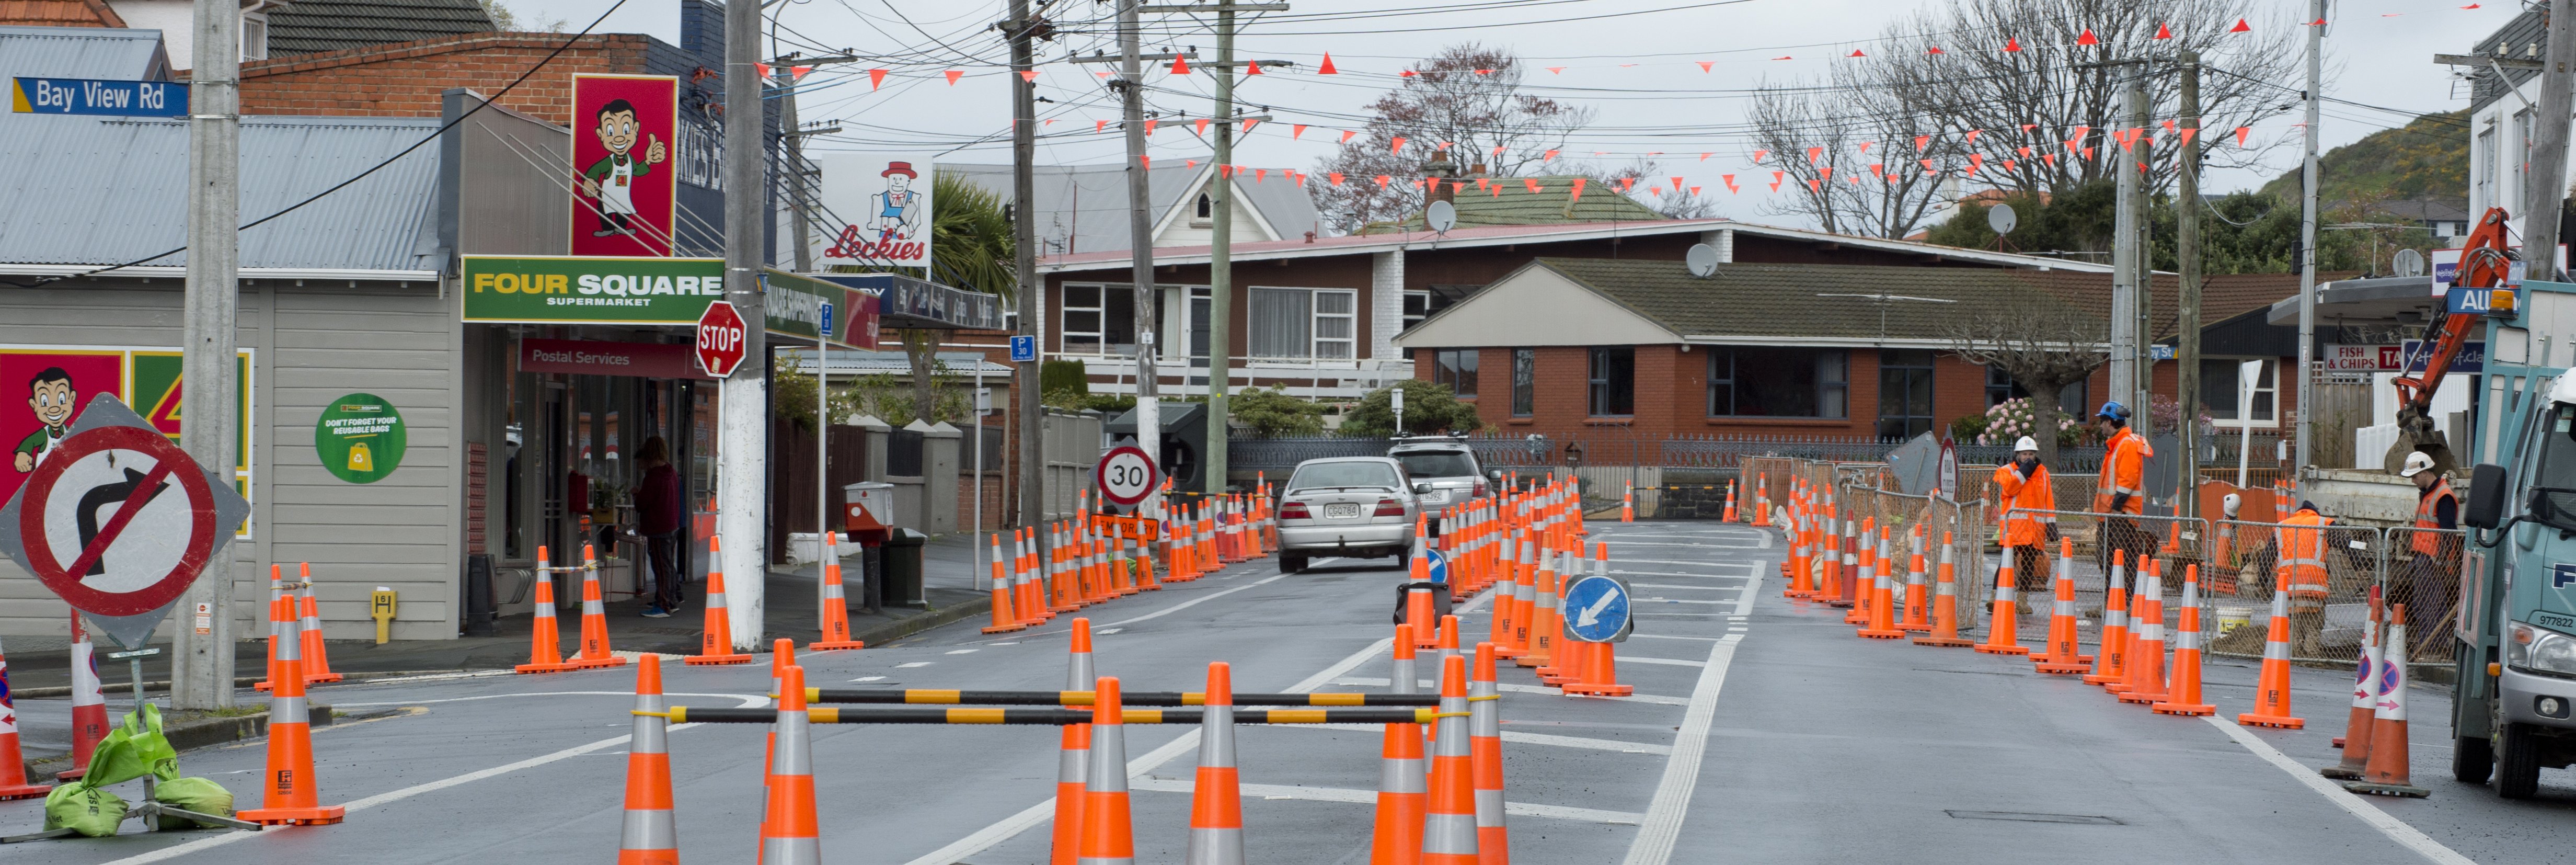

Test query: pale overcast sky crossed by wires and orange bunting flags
[505,0,2520,224]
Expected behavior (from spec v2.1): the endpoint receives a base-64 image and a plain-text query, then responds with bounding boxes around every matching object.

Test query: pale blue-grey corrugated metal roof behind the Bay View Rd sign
[0,116,441,270]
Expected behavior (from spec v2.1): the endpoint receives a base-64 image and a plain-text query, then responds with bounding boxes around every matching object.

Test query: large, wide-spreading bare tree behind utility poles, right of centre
[1754,0,2301,237]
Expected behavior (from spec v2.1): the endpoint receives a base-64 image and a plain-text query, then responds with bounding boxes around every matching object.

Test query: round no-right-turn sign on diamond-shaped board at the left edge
[0,394,250,649]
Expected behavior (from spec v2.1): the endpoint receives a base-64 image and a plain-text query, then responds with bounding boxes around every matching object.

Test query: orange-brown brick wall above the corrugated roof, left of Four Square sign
[242,33,652,123]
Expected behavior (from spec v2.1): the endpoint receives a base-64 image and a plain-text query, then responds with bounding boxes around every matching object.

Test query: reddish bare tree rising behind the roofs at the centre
[1306,41,1592,232]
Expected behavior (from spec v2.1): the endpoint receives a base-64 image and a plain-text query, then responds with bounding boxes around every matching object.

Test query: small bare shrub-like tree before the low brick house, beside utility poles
[1942,306,2110,466]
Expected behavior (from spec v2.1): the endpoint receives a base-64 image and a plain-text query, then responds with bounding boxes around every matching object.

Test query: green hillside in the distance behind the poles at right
[2262,111,2468,201]
